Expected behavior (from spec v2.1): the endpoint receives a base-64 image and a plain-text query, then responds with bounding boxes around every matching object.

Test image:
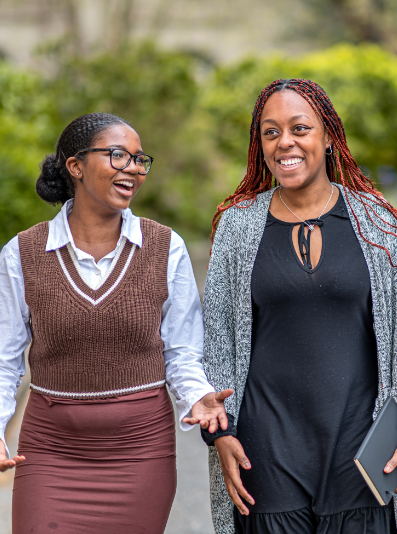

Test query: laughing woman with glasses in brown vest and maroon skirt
[0,113,232,534]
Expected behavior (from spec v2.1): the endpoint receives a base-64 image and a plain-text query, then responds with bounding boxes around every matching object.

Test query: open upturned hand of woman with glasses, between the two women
[182,389,234,434]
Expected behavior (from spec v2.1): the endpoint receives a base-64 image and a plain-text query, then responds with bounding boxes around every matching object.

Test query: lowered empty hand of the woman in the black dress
[214,436,255,515]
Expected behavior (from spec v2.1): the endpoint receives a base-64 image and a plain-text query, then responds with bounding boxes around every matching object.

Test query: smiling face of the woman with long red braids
[260,90,332,193]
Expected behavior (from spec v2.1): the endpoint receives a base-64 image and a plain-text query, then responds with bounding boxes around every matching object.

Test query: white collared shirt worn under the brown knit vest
[0,200,214,456]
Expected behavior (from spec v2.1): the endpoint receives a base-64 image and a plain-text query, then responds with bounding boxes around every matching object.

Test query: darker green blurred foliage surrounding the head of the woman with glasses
[0,44,223,244]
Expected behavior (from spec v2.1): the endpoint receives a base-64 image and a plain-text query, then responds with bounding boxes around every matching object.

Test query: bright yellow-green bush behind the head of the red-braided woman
[203,45,397,175]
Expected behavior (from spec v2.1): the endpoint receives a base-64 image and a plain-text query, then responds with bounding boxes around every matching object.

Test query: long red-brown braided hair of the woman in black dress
[211,78,397,267]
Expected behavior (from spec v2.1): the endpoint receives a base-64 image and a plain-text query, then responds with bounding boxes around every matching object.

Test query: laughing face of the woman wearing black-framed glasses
[66,124,146,213]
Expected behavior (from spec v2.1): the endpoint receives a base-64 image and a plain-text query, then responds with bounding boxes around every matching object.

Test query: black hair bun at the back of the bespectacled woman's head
[36,154,72,204]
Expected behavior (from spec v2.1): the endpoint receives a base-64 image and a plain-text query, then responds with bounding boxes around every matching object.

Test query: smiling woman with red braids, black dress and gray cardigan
[202,79,397,534]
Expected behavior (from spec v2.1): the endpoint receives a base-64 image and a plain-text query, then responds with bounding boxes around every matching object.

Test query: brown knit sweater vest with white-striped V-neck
[18,218,171,399]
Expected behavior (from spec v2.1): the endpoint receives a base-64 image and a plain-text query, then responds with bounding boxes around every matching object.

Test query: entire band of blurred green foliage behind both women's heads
[0,43,397,244]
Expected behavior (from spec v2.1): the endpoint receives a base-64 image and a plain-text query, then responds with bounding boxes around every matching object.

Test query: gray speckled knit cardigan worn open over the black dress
[203,184,397,534]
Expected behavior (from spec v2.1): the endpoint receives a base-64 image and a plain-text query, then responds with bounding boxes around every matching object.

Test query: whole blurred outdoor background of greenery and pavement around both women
[0,0,397,534]
